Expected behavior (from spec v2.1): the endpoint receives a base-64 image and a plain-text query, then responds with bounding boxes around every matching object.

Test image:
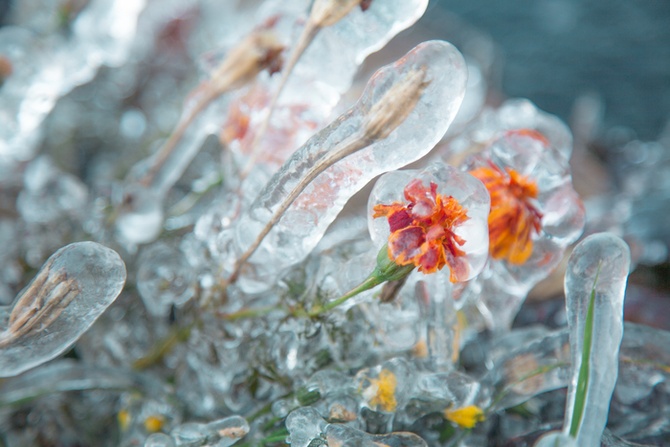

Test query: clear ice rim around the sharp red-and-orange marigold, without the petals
[368,162,490,281]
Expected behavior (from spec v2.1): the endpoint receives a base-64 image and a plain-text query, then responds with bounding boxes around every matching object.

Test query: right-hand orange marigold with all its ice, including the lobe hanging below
[461,129,585,331]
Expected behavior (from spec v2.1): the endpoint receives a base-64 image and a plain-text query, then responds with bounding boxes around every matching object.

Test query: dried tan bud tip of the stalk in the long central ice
[364,67,430,140]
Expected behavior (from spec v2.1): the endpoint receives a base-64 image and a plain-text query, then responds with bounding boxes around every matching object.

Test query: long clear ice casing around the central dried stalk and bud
[231,41,467,288]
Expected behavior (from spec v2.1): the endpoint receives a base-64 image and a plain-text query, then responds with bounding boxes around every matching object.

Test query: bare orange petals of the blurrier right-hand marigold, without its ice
[470,163,542,265]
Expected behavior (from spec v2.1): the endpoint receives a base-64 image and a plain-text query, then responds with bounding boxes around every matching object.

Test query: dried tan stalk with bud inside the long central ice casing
[227,66,428,284]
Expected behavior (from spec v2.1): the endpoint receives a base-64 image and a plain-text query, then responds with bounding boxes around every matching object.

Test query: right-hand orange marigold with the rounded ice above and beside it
[465,129,583,272]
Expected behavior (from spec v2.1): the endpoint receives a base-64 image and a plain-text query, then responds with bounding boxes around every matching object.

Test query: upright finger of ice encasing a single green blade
[564,233,630,445]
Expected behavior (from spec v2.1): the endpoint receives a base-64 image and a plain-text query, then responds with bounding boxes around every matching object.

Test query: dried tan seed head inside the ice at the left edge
[0,267,81,348]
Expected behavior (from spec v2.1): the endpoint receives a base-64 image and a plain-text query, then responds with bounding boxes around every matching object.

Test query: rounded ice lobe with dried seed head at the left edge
[0,242,126,377]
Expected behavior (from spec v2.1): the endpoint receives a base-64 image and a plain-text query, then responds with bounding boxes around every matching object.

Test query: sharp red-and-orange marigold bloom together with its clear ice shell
[370,164,489,282]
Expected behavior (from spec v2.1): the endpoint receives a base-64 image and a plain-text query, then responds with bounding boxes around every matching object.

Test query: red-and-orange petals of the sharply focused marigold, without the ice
[373,179,468,282]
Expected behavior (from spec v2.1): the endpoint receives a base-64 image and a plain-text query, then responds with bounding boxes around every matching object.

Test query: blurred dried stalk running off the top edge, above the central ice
[240,0,368,179]
